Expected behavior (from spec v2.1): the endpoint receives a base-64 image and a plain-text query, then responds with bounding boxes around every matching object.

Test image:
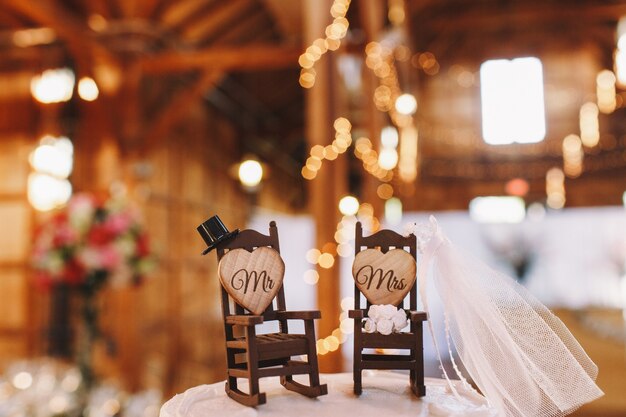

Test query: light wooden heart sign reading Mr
[217,246,285,314]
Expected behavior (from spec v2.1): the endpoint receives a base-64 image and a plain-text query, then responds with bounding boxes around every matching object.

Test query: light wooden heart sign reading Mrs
[352,249,416,306]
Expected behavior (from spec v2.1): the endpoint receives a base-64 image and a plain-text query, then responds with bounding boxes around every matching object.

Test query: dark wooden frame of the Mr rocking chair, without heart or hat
[216,221,328,407]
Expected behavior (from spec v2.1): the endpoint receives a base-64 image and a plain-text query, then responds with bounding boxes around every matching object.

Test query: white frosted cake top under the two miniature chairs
[160,371,497,417]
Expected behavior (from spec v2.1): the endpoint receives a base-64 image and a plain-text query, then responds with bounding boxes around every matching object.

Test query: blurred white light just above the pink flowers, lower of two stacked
[28,173,72,211]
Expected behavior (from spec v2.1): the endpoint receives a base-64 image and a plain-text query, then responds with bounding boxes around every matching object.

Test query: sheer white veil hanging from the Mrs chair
[415,217,603,417]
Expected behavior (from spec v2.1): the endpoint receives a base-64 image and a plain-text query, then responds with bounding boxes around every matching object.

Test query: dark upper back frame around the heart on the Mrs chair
[354,222,417,310]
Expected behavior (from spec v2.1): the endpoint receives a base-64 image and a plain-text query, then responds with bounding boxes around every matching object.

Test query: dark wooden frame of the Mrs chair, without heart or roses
[349,222,427,397]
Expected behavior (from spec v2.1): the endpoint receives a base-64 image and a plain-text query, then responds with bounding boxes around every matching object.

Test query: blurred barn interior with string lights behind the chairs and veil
[0,0,626,416]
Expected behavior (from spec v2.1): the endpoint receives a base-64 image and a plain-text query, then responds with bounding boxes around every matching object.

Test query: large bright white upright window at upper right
[480,57,546,145]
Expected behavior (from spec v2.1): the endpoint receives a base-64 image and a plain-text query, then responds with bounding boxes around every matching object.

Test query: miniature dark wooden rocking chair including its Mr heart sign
[216,221,328,407]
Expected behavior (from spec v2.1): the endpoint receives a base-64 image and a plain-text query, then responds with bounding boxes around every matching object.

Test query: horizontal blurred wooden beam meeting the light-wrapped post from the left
[139,45,301,73]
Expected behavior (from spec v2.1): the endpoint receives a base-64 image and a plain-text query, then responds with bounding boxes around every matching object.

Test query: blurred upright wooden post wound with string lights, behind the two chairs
[303,0,347,372]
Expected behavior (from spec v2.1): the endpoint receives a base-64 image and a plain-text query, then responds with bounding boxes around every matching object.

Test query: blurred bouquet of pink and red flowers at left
[33,194,154,288]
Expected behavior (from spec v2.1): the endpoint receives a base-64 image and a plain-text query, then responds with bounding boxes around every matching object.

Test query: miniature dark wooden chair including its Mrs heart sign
[349,222,427,397]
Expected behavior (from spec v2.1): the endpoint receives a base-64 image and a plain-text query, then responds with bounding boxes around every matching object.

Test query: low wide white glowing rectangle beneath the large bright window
[469,197,526,223]
